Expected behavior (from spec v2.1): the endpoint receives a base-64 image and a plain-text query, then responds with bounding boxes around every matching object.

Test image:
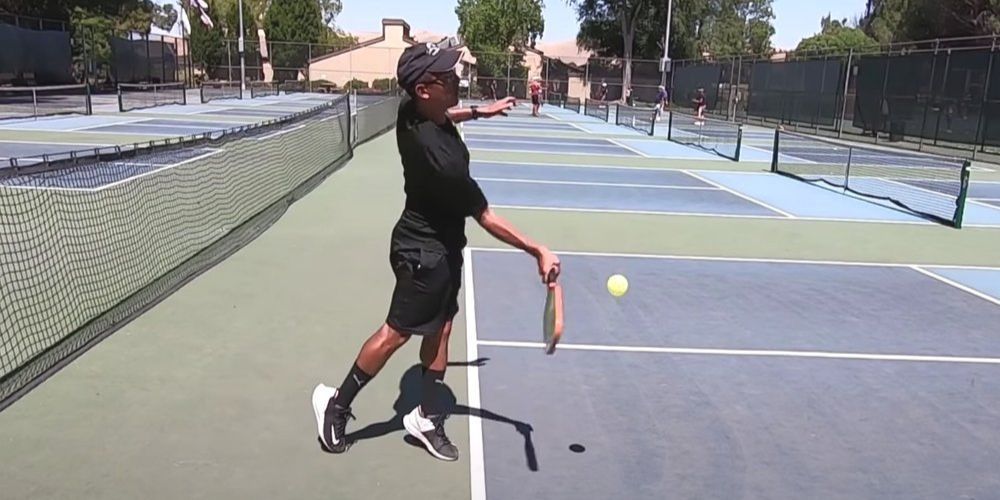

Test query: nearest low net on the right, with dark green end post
[771,130,970,227]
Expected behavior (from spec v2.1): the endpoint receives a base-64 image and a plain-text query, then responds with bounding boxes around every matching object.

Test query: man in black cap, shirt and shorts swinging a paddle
[312,44,559,460]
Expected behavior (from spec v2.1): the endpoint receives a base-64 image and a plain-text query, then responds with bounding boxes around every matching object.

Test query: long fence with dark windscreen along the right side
[670,37,1000,164]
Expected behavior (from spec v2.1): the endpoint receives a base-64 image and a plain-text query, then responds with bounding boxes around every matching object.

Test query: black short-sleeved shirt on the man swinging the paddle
[392,96,487,254]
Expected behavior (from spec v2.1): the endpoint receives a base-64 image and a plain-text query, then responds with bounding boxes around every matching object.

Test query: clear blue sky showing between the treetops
[336,0,866,49]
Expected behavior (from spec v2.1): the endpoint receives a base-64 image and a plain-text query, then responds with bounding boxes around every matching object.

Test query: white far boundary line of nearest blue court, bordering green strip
[469,246,1000,271]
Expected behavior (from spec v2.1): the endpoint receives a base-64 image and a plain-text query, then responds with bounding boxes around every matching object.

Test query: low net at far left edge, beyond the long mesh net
[0,84,92,119]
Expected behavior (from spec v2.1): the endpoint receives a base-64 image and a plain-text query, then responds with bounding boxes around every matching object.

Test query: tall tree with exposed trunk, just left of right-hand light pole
[570,0,656,98]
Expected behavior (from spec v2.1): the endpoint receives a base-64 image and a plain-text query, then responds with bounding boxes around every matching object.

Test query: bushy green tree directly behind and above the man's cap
[455,0,545,82]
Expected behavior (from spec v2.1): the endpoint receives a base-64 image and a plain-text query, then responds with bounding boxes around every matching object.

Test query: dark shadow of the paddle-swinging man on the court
[345,358,538,471]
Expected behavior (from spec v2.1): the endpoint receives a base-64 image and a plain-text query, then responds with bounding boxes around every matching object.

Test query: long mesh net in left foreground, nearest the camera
[0,96,353,409]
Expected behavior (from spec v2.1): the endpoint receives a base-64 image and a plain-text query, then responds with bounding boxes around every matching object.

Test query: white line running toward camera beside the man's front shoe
[464,248,486,500]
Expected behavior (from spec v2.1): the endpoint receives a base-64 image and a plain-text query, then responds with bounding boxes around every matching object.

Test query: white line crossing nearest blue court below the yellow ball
[479,340,1000,365]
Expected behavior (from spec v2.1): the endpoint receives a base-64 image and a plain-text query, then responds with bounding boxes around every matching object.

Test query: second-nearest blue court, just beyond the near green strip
[471,160,1000,227]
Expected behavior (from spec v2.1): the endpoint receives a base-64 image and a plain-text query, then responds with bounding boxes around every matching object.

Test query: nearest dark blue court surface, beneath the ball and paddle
[465,249,1000,500]
